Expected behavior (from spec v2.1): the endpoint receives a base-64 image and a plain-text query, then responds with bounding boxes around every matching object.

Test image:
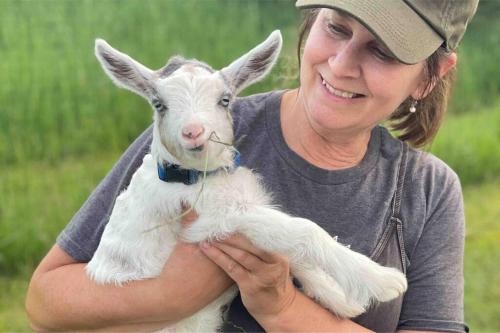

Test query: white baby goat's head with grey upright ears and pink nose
[95,31,282,170]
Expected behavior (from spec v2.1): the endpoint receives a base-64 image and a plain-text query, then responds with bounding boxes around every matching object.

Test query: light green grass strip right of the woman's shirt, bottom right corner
[464,178,500,332]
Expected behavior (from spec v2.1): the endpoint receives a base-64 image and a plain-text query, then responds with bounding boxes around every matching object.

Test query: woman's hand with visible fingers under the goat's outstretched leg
[201,234,297,320]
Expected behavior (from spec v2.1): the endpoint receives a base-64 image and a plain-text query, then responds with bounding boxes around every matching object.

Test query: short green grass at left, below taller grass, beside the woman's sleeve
[0,153,118,276]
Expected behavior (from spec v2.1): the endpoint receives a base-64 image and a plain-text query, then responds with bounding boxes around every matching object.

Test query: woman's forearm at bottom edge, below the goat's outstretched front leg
[255,290,372,332]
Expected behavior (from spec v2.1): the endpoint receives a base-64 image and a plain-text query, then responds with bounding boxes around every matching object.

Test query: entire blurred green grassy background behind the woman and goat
[0,0,500,332]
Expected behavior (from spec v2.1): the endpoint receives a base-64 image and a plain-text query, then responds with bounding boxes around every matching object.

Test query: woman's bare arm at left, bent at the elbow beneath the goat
[26,226,233,331]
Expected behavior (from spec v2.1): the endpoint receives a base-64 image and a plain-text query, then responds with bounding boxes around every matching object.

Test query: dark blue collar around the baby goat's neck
[157,151,240,185]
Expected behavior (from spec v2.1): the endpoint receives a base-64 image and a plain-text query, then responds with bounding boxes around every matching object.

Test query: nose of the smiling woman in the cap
[328,42,361,78]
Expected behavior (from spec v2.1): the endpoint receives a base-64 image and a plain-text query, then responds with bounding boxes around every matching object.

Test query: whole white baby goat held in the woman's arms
[86,31,406,332]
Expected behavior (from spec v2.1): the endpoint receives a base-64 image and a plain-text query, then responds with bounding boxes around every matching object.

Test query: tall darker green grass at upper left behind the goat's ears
[0,0,298,166]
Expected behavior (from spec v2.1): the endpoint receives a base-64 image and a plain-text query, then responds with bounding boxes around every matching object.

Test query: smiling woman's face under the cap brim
[292,9,436,163]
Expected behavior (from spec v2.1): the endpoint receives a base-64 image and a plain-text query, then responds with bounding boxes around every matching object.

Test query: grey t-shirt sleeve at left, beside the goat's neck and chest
[56,127,152,262]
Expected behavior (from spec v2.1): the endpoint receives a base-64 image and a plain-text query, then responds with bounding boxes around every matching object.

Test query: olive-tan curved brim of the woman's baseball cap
[295,0,443,64]
